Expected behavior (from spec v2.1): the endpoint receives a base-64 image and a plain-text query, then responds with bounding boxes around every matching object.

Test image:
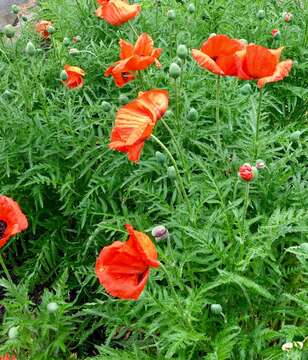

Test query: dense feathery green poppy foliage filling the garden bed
[0,0,308,360]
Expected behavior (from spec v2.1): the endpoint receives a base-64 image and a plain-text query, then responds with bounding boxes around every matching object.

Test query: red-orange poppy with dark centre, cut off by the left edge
[0,195,28,248]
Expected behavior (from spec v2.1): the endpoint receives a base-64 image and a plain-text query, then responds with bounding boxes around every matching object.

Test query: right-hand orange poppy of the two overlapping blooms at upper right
[237,44,293,88]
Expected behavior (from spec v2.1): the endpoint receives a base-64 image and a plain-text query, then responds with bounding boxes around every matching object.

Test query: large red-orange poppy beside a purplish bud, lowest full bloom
[95,224,160,300]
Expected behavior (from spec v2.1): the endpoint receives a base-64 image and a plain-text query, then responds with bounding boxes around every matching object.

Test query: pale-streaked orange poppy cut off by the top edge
[96,0,141,26]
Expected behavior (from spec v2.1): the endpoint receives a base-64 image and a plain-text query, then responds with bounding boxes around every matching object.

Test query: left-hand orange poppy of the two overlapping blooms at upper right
[192,35,245,76]
